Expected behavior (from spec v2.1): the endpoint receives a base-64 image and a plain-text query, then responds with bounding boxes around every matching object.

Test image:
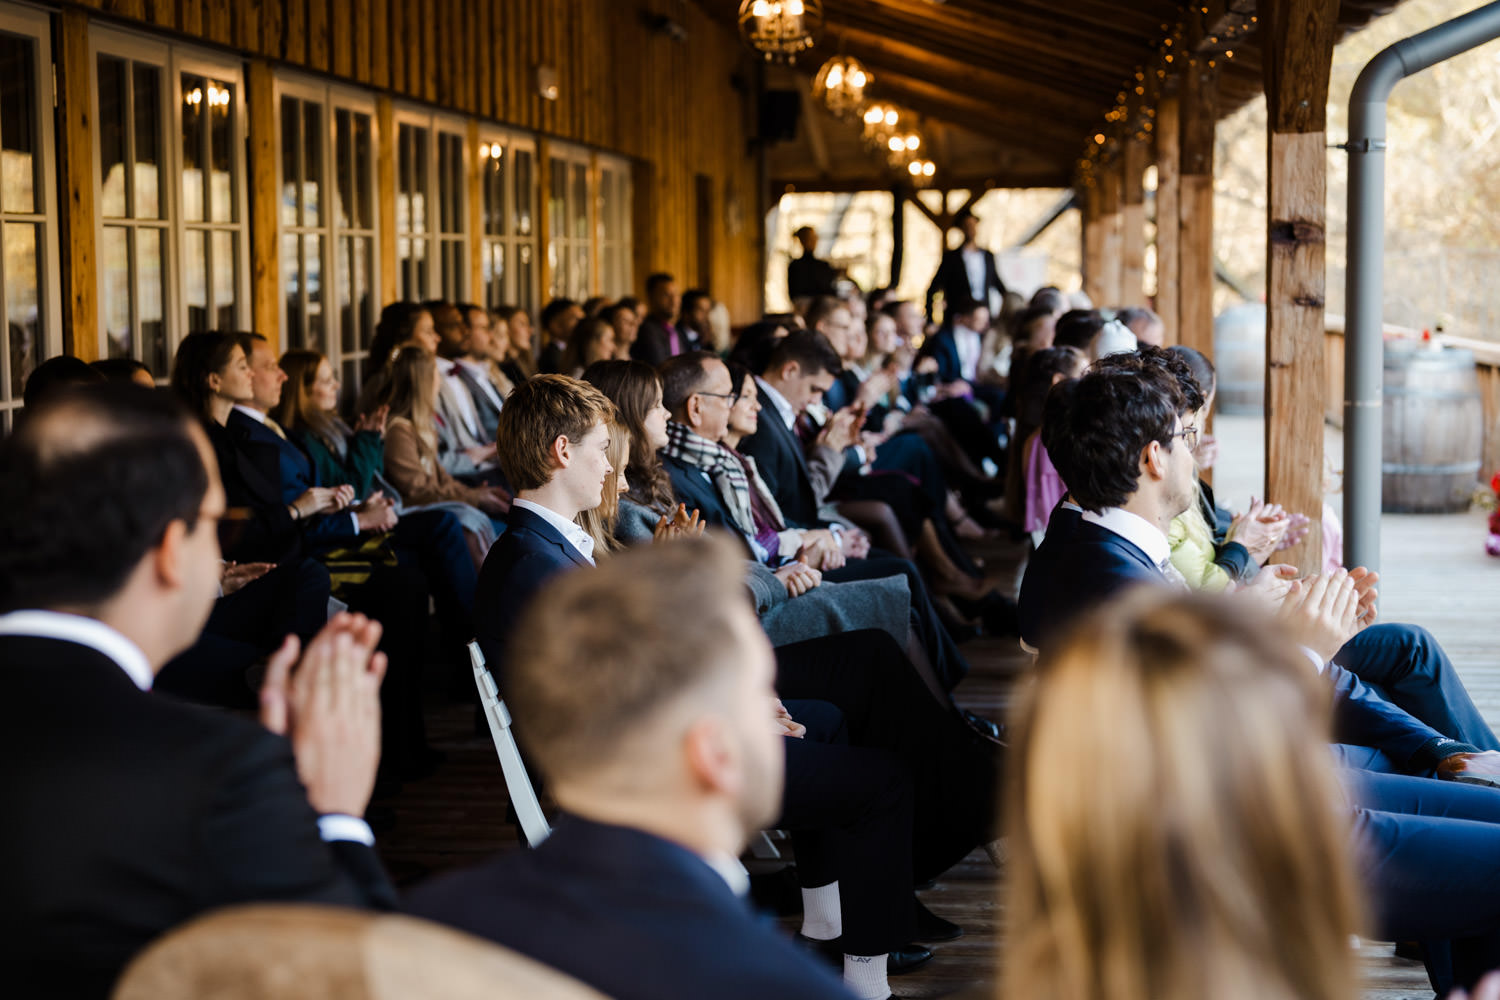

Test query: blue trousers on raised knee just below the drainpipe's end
[1334,625,1500,750]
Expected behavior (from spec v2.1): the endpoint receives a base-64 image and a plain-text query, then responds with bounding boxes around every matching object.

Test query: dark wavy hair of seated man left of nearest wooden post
[1041,355,1190,511]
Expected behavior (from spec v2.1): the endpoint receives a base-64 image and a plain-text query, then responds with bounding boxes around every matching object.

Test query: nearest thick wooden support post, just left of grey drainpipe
[1260,0,1340,573]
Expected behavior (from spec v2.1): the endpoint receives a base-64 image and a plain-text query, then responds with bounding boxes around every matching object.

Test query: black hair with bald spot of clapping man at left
[0,382,209,612]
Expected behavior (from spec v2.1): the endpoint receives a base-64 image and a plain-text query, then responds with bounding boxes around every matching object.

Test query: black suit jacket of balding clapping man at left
[0,636,396,997]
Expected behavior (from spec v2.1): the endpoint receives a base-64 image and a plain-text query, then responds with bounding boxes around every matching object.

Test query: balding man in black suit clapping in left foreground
[0,385,395,997]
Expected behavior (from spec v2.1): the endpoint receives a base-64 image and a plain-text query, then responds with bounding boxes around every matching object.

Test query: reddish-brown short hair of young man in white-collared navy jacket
[495,375,615,490]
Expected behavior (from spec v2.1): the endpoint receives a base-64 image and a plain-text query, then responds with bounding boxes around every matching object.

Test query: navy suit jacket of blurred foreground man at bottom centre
[407,816,849,1000]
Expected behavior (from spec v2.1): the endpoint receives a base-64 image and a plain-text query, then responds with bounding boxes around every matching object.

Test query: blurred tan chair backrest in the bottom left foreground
[114,904,615,1000]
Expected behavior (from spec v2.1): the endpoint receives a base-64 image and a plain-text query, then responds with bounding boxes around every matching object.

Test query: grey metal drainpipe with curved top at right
[1343,1,1500,570]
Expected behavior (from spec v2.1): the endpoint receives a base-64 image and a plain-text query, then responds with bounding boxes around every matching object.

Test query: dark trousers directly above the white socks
[777,700,915,955]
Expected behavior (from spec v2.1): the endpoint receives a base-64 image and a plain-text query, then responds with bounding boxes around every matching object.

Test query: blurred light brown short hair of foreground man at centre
[506,536,749,780]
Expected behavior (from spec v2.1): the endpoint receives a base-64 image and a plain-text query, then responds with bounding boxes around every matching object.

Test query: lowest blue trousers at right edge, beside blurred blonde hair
[1343,769,1500,997]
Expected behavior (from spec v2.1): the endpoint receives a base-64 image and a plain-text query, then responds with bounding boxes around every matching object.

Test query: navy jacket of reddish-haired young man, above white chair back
[474,507,590,693]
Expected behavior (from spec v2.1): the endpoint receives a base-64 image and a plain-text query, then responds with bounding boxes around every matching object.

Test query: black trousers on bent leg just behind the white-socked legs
[776,630,999,888]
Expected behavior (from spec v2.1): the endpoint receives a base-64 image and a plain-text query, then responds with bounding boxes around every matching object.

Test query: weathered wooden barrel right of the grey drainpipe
[1380,340,1484,514]
